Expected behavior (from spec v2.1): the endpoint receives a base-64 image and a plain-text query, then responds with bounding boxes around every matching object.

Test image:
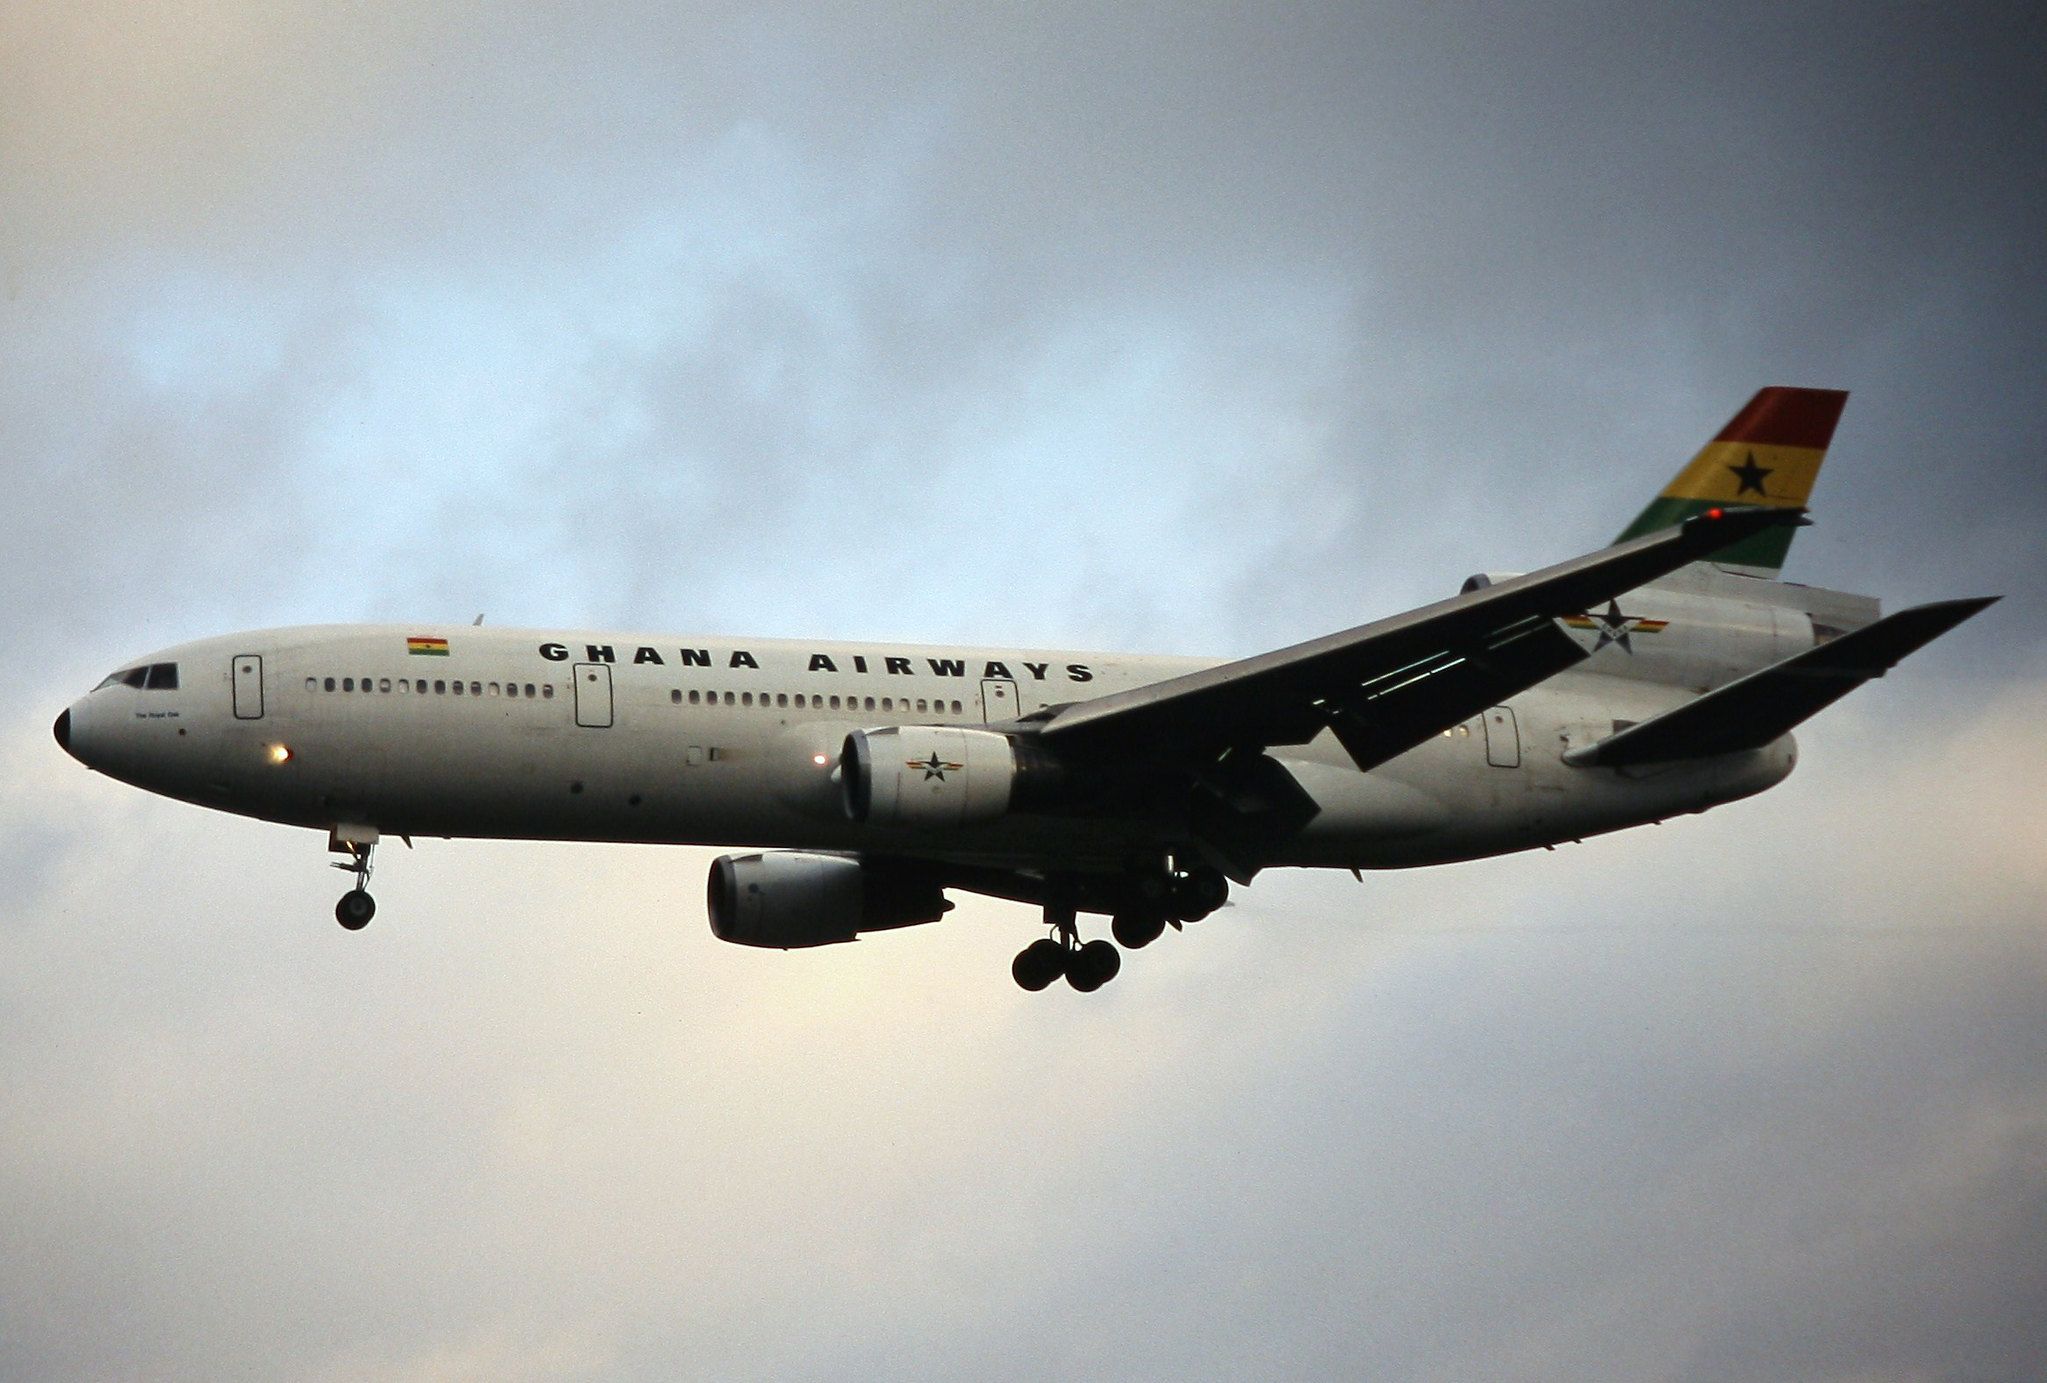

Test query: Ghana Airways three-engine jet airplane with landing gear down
[53,387,1998,992]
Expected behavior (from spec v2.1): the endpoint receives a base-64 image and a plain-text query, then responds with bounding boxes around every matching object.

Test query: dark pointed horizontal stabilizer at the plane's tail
[1564,595,1998,767]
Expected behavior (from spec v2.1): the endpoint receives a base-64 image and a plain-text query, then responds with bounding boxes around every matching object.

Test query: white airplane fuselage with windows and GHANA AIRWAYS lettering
[56,591,1814,869]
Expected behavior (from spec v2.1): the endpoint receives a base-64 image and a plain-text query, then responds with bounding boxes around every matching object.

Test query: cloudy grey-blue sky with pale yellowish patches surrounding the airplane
[0,0,2047,1381]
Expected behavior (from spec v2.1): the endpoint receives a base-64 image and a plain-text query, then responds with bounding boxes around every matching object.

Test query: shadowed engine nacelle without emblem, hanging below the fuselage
[708,849,952,951]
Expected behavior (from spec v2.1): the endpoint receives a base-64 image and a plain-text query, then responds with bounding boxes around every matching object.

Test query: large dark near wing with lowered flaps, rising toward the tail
[1038,507,1808,773]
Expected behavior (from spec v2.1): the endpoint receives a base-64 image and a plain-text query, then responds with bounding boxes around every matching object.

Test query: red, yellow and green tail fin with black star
[1615,387,1848,577]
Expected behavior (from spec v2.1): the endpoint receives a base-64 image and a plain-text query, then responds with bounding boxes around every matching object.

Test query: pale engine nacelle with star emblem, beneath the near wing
[839,724,1030,827]
